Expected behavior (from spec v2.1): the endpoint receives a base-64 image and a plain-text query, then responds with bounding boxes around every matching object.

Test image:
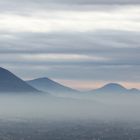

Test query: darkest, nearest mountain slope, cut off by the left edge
[0,67,39,93]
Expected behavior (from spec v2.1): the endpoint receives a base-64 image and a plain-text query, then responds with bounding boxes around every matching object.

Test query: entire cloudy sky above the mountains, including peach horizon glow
[0,0,140,90]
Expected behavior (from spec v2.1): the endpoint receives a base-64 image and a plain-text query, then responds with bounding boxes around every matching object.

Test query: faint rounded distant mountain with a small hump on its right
[90,83,140,93]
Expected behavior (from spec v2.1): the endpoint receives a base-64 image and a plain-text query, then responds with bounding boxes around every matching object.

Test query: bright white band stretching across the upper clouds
[0,6,140,32]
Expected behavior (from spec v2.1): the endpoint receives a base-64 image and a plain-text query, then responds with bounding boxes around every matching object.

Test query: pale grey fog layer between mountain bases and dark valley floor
[0,94,140,122]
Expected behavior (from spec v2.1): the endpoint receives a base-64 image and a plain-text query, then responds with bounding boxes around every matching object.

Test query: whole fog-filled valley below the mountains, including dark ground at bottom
[0,93,140,140]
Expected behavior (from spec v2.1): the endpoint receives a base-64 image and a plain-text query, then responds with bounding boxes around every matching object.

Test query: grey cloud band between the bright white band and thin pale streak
[0,30,140,54]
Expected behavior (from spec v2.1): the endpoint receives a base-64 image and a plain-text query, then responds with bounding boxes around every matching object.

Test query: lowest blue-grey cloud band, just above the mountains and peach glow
[2,64,140,82]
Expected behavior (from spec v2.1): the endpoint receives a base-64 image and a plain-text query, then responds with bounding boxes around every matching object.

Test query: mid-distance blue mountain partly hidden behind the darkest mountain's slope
[26,78,78,93]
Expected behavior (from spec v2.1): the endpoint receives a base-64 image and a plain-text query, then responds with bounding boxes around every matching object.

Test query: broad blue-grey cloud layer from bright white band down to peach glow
[0,30,140,81]
